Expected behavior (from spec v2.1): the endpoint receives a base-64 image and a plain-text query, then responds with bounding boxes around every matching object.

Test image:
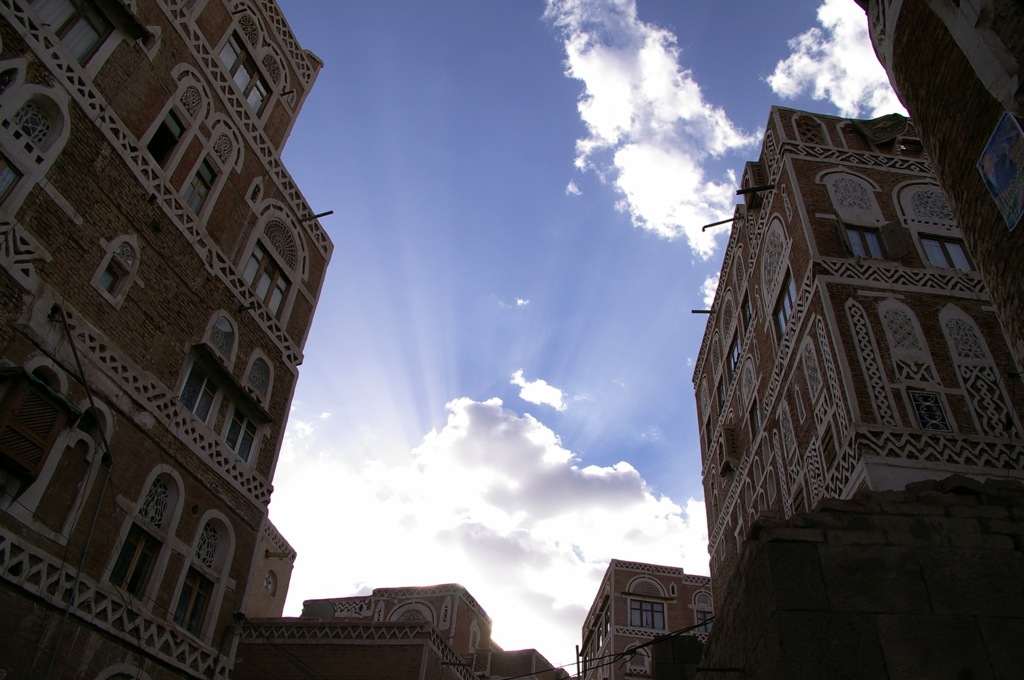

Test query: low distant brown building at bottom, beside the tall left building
[231,584,568,680]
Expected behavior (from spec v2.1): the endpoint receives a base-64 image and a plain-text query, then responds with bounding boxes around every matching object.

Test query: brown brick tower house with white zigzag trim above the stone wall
[693,108,1024,606]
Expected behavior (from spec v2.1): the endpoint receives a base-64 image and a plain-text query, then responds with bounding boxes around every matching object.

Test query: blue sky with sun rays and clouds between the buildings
[270,0,903,665]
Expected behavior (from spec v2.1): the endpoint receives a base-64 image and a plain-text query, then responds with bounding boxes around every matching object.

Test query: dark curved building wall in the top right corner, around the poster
[857,0,1024,368]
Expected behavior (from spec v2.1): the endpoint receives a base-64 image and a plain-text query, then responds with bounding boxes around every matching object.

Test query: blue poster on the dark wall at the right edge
[978,112,1024,229]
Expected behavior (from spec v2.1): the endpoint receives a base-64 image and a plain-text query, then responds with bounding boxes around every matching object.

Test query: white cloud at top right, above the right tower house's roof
[767,0,906,118]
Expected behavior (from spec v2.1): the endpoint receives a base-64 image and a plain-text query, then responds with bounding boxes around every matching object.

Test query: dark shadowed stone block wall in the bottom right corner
[702,476,1024,680]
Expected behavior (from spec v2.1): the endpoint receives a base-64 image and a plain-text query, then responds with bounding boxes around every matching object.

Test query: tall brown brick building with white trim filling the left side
[0,0,332,680]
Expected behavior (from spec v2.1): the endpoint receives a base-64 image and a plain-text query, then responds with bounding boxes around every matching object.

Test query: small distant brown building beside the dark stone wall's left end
[580,559,714,680]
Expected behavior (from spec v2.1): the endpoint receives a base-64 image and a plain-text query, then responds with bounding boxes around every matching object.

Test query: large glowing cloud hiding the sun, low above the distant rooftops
[271,398,708,664]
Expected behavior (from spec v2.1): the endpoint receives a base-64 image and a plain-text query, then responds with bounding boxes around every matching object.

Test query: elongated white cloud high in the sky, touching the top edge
[545,0,757,258]
